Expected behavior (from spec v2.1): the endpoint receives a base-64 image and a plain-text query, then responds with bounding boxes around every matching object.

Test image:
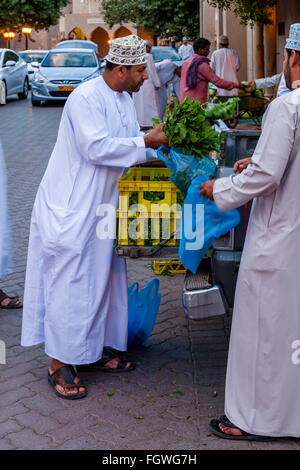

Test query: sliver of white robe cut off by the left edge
[0,142,13,278]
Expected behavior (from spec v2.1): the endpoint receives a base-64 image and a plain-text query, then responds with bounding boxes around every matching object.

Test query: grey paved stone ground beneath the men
[0,93,300,450]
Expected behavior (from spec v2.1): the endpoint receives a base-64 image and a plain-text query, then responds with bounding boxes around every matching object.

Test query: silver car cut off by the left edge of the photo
[0,49,29,102]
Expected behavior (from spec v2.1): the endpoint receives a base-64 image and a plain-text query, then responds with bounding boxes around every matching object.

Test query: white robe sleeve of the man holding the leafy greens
[68,95,146,167]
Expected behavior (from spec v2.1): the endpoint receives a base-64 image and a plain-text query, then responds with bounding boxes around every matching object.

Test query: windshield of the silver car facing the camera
[42,52,97,67]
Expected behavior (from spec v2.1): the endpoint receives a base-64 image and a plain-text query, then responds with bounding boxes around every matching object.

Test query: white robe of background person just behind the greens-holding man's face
[132,53,160,127]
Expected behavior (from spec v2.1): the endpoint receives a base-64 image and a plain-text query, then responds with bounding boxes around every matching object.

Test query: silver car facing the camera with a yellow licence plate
[31,49,102,106]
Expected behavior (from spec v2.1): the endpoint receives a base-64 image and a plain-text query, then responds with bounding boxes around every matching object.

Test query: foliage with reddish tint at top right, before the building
[207,0,277,26]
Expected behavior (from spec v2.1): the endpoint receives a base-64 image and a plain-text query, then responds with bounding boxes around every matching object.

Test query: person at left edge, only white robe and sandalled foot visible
[0,138,22,309]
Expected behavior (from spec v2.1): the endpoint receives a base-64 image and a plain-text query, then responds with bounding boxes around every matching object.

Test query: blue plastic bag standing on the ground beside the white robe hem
[127,279,161,350]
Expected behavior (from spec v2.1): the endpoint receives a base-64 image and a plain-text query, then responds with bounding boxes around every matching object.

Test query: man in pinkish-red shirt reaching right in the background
[180,38,243,103]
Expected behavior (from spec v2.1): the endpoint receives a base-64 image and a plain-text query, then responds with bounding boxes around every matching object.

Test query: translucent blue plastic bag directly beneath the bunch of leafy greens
[157,146,217,196]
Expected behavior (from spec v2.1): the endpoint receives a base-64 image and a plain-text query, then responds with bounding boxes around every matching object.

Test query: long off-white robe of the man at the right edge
[214,89,300,437]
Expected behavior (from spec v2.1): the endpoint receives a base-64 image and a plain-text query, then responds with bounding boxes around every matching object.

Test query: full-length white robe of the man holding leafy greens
[21,77,153,364]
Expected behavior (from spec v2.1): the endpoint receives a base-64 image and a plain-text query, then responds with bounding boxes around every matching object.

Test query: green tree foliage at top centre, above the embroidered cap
[102,0,199,41]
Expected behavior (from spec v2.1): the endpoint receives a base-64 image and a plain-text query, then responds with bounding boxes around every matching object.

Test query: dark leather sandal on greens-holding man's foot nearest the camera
[48,364,87,400]
